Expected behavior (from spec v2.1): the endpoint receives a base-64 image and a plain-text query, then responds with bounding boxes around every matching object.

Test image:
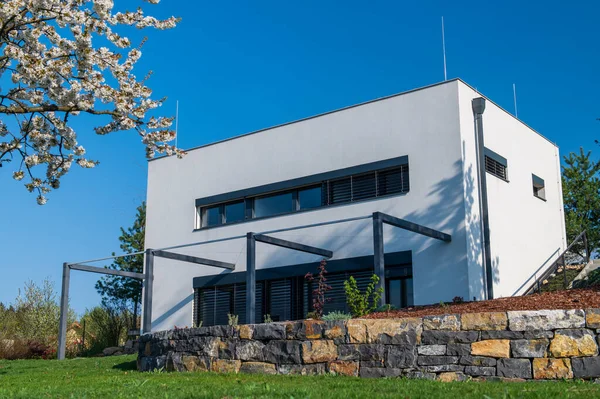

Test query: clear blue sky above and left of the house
[0,0,600,312]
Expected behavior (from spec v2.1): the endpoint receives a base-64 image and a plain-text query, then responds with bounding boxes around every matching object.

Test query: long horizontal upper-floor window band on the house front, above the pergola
[197,163,410,228]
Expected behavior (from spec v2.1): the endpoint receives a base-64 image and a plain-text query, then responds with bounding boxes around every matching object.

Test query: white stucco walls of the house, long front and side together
[146,80,565,330]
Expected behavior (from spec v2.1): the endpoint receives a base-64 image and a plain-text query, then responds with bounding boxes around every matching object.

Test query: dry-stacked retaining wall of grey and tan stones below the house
[138,309,600,381]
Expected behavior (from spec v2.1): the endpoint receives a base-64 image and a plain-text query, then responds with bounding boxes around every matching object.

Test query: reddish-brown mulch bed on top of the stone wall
[365,287,600,319]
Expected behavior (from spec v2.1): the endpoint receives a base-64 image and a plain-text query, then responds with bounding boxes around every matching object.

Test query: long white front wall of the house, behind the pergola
[146,81,472,330]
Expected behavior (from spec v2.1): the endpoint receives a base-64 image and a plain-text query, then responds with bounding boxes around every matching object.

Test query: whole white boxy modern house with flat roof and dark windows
[146,79,566,330]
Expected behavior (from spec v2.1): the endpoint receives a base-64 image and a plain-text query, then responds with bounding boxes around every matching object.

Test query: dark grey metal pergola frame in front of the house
[58,212,452,359]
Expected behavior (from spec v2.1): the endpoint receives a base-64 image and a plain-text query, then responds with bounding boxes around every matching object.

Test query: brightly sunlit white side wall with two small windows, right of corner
[459,84,566,297]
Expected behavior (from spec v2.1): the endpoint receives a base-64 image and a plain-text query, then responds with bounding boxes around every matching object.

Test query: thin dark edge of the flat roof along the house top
[148,78,558,162]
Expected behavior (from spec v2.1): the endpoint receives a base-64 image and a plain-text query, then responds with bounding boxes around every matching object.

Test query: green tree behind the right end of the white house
[562,148,600,256]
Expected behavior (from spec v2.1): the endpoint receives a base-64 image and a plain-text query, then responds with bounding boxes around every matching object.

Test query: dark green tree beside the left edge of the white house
[96,202,146,329]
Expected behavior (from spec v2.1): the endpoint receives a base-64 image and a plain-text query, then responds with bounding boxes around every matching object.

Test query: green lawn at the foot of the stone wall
[0,356,600,399]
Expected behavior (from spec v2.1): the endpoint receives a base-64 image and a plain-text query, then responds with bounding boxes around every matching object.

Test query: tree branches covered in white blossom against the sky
[0,0,183,205]
